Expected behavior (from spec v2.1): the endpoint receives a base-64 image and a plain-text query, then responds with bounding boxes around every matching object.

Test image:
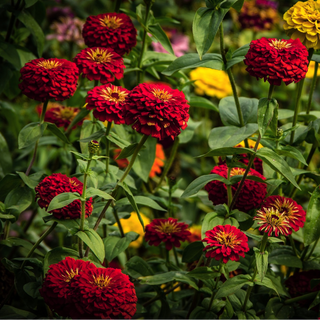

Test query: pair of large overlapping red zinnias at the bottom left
[40,257,137,320]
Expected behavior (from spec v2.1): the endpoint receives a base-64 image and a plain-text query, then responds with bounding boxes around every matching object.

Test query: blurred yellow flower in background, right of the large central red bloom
[190,67,232,99]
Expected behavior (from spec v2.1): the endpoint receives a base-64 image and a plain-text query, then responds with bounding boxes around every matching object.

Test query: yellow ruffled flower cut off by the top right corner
[283,0,320,49]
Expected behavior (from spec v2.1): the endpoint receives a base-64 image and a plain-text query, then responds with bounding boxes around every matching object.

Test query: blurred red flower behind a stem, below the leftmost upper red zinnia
[37,102,83,129]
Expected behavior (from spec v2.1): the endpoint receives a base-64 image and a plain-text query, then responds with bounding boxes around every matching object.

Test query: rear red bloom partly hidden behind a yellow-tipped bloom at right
[261,196,306,231]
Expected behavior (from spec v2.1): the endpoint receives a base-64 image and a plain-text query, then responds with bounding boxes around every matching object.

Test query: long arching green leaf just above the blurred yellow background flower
[162,53,223,76]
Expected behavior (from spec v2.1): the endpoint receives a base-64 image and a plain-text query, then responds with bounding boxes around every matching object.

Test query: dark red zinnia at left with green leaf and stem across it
[35,173,93,219]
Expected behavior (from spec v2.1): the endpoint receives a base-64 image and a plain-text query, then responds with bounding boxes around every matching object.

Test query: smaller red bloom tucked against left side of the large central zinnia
[86,83,130,124]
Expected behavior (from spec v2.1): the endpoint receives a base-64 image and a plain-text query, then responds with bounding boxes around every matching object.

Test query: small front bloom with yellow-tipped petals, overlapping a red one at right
[253,207,292,237]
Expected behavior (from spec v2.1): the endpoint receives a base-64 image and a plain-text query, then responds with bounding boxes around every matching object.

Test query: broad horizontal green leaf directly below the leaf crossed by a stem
[208,123,258,149]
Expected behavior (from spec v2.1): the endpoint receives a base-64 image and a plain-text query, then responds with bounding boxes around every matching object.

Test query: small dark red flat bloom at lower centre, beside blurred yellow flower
[145,218,191,250]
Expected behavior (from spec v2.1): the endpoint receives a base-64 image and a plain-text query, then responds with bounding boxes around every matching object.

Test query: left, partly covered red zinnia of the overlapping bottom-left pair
[39,257,96,317]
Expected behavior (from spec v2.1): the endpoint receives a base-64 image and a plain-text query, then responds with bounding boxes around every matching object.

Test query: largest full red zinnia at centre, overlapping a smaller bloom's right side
[124,83,189,140]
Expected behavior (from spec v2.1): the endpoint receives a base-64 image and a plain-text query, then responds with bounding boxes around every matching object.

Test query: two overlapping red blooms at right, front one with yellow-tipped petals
[254,196,306,237]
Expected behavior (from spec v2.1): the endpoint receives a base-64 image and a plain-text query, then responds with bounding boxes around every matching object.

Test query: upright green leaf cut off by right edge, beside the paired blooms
[303,186,320,246]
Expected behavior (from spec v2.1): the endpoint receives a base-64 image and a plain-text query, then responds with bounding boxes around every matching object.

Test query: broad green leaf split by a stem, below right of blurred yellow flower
[219,97,259,127]
